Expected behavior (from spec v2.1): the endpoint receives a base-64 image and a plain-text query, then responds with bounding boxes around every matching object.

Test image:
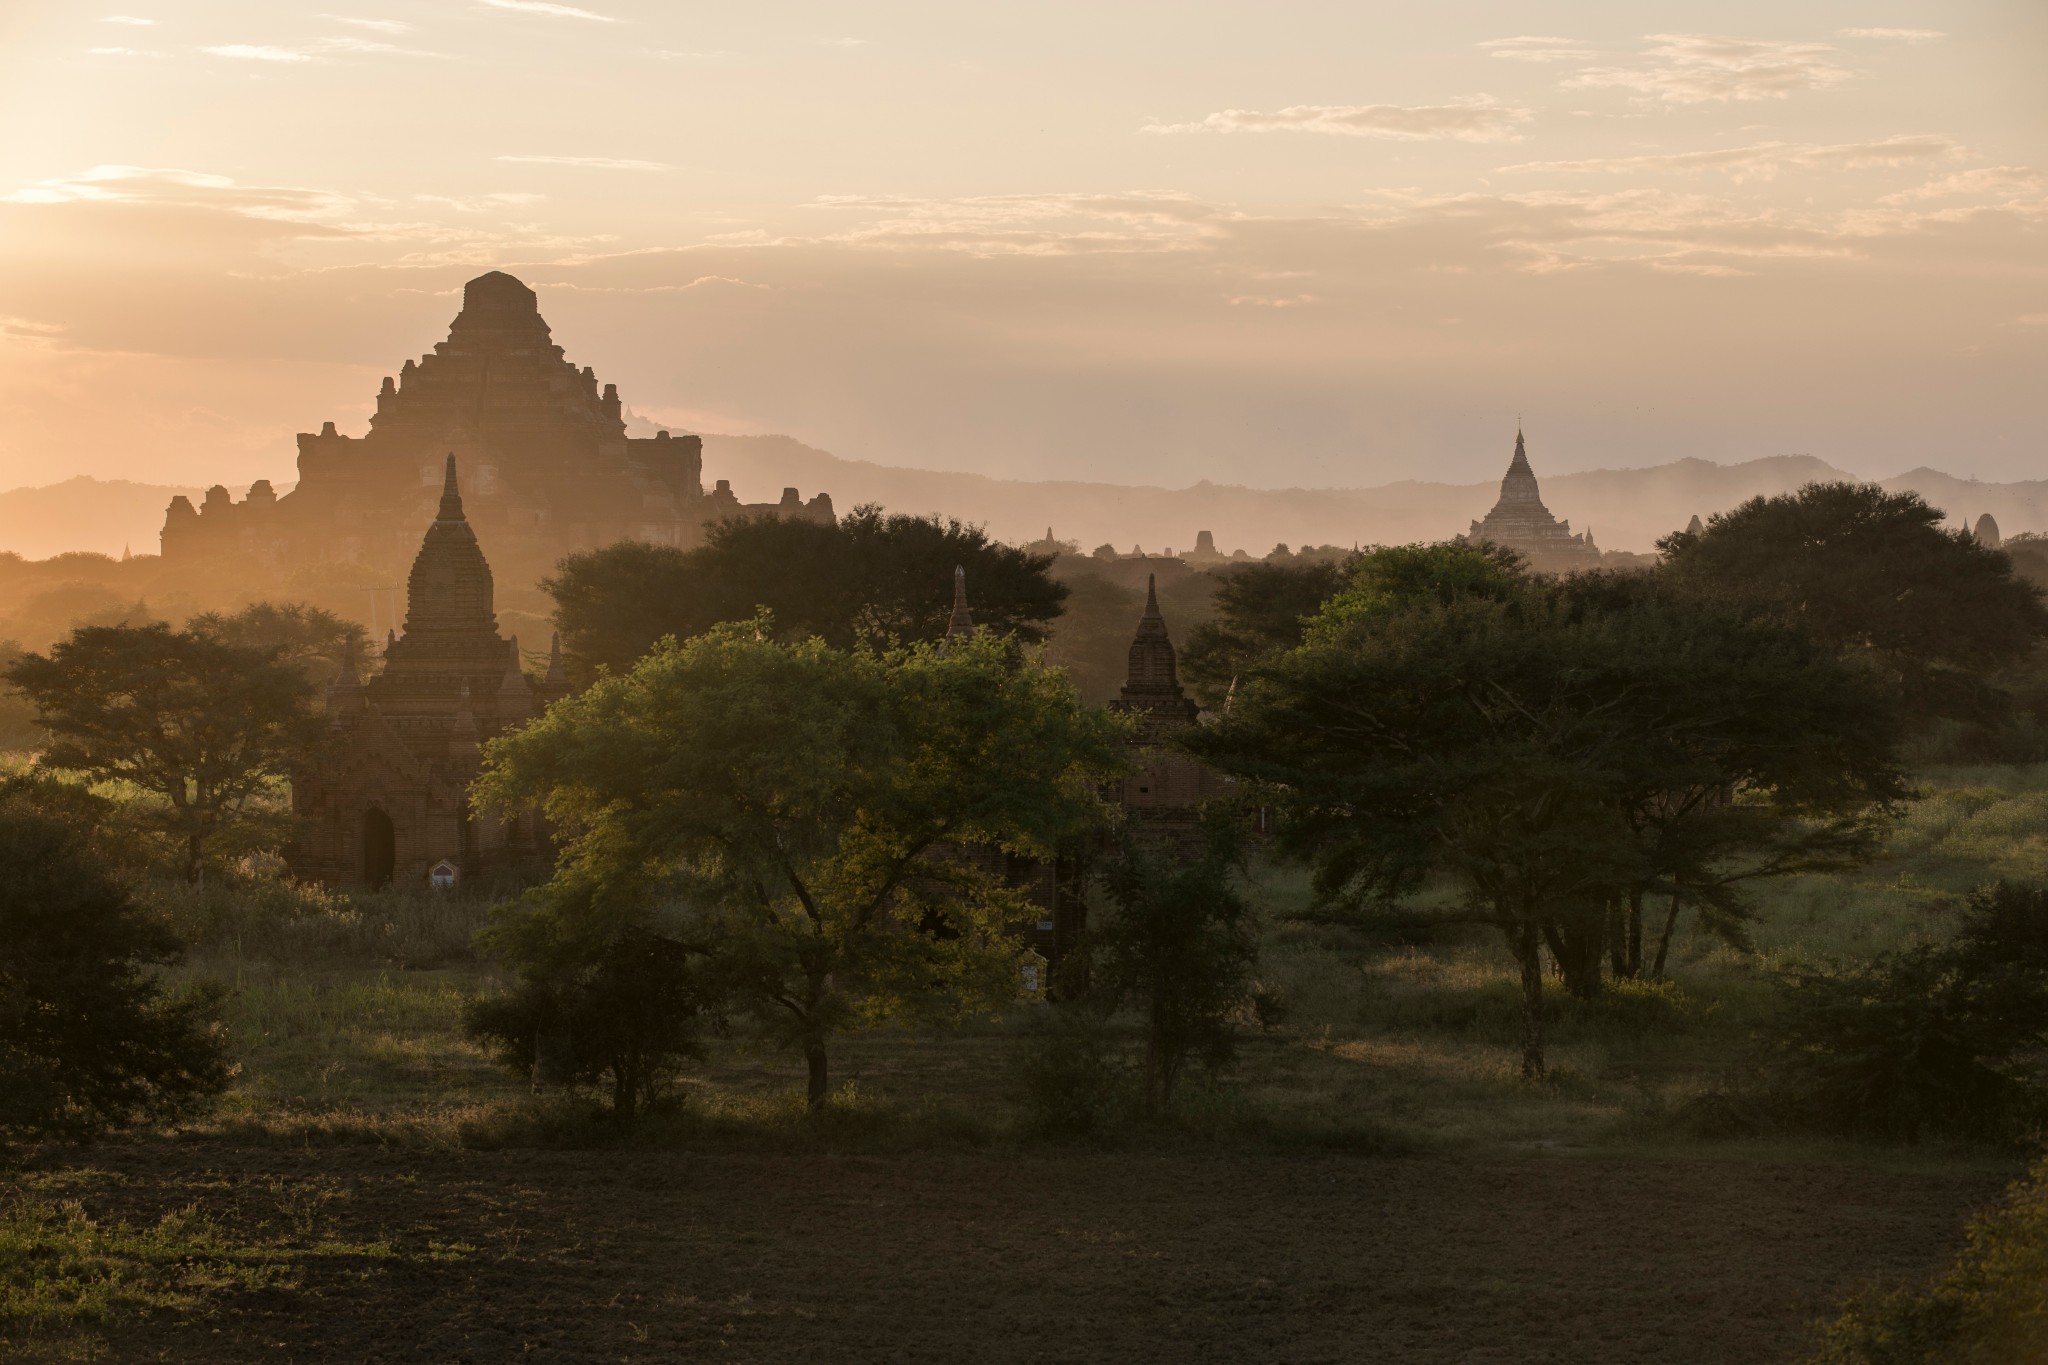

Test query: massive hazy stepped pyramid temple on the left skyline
[164,270,834,581]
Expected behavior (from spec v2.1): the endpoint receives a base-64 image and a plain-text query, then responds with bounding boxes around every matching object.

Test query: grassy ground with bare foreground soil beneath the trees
[0,769,2048,1361]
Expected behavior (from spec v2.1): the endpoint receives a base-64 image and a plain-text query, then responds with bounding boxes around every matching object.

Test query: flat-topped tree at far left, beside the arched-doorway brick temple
[6,622,324,882]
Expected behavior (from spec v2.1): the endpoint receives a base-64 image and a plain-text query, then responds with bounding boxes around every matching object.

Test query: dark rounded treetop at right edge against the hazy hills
[1657,483,2048,718]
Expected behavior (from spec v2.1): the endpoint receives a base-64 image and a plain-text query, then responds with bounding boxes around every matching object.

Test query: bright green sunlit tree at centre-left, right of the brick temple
[475,618,1122,1107]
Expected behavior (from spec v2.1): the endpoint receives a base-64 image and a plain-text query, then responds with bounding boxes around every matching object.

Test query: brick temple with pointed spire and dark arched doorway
[291,454,569,888]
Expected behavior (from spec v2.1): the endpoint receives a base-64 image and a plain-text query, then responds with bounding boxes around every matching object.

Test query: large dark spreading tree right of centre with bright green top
[1190,544,1903,1076]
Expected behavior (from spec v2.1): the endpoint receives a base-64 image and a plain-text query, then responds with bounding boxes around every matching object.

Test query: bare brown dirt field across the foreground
[32,1142,2003,1365]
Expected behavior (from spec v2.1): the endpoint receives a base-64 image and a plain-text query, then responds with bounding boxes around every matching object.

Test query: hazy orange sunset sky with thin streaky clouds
[0,0,2048,495]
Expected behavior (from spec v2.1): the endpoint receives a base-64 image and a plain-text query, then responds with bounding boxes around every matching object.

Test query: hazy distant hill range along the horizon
[0,436,2048,559]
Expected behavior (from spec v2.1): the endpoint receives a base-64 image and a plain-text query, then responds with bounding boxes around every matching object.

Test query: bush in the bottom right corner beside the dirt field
[1810,1162,2048,1365]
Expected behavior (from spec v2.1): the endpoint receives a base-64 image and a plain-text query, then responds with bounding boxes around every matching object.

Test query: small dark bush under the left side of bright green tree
[465,929,717,1128]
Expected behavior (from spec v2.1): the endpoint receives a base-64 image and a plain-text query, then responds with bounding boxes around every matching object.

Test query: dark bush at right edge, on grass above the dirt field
[1765,882,2048,1140]
